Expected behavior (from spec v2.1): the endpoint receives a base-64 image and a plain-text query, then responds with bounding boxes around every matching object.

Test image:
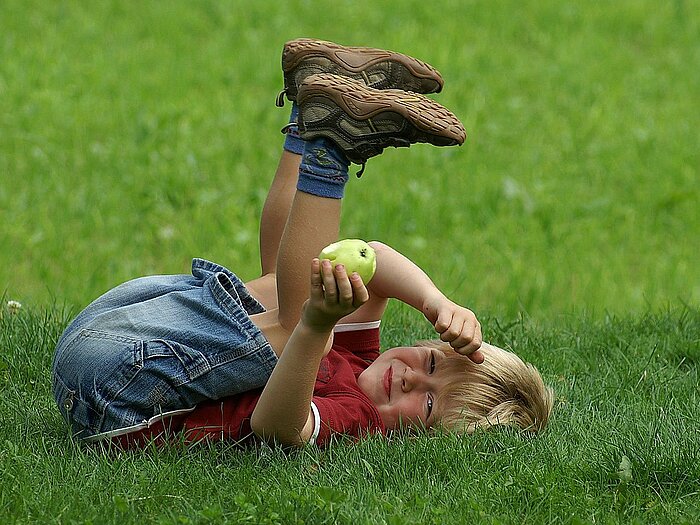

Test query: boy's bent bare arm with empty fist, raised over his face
[364,241,484,363]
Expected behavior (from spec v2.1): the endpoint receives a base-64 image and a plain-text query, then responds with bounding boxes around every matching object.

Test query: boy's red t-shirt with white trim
[112,325,385,447]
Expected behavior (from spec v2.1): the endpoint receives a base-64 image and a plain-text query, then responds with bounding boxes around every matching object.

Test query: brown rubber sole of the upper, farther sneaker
[282,38,444,95]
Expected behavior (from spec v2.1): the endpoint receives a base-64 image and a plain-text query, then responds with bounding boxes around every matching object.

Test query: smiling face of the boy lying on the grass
[357,346,447,429]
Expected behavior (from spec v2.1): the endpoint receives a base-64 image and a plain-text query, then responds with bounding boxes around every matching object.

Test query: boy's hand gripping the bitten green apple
[301,259,369,331]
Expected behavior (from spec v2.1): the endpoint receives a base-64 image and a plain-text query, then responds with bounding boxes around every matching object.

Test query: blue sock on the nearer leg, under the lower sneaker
[297,138,350,199]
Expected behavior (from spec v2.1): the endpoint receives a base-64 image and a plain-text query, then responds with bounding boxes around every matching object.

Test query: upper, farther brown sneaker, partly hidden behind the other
[277,38,443,107]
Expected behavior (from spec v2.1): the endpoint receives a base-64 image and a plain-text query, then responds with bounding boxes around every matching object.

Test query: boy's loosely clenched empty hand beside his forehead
[423,295,484,364]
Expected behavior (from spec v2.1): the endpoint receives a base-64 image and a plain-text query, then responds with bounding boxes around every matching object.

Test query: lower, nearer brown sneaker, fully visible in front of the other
[297,74,466,164]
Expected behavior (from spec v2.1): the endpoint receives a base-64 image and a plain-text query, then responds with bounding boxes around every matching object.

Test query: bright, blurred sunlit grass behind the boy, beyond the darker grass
[0,0,700,319]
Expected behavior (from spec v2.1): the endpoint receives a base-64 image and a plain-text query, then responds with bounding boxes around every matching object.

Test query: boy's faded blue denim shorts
[52,259,277,439]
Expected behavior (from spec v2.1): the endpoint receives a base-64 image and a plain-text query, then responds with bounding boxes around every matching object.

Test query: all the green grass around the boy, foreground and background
[0,0,700,524]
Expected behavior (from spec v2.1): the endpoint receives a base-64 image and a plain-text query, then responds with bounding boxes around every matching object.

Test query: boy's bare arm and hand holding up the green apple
[251,259,369,446]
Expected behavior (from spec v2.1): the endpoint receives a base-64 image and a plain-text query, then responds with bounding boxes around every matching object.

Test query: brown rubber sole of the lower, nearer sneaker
[298,74,467,146]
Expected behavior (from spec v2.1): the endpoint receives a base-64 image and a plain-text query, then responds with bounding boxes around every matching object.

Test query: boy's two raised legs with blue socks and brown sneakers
[249,39,464,330]
